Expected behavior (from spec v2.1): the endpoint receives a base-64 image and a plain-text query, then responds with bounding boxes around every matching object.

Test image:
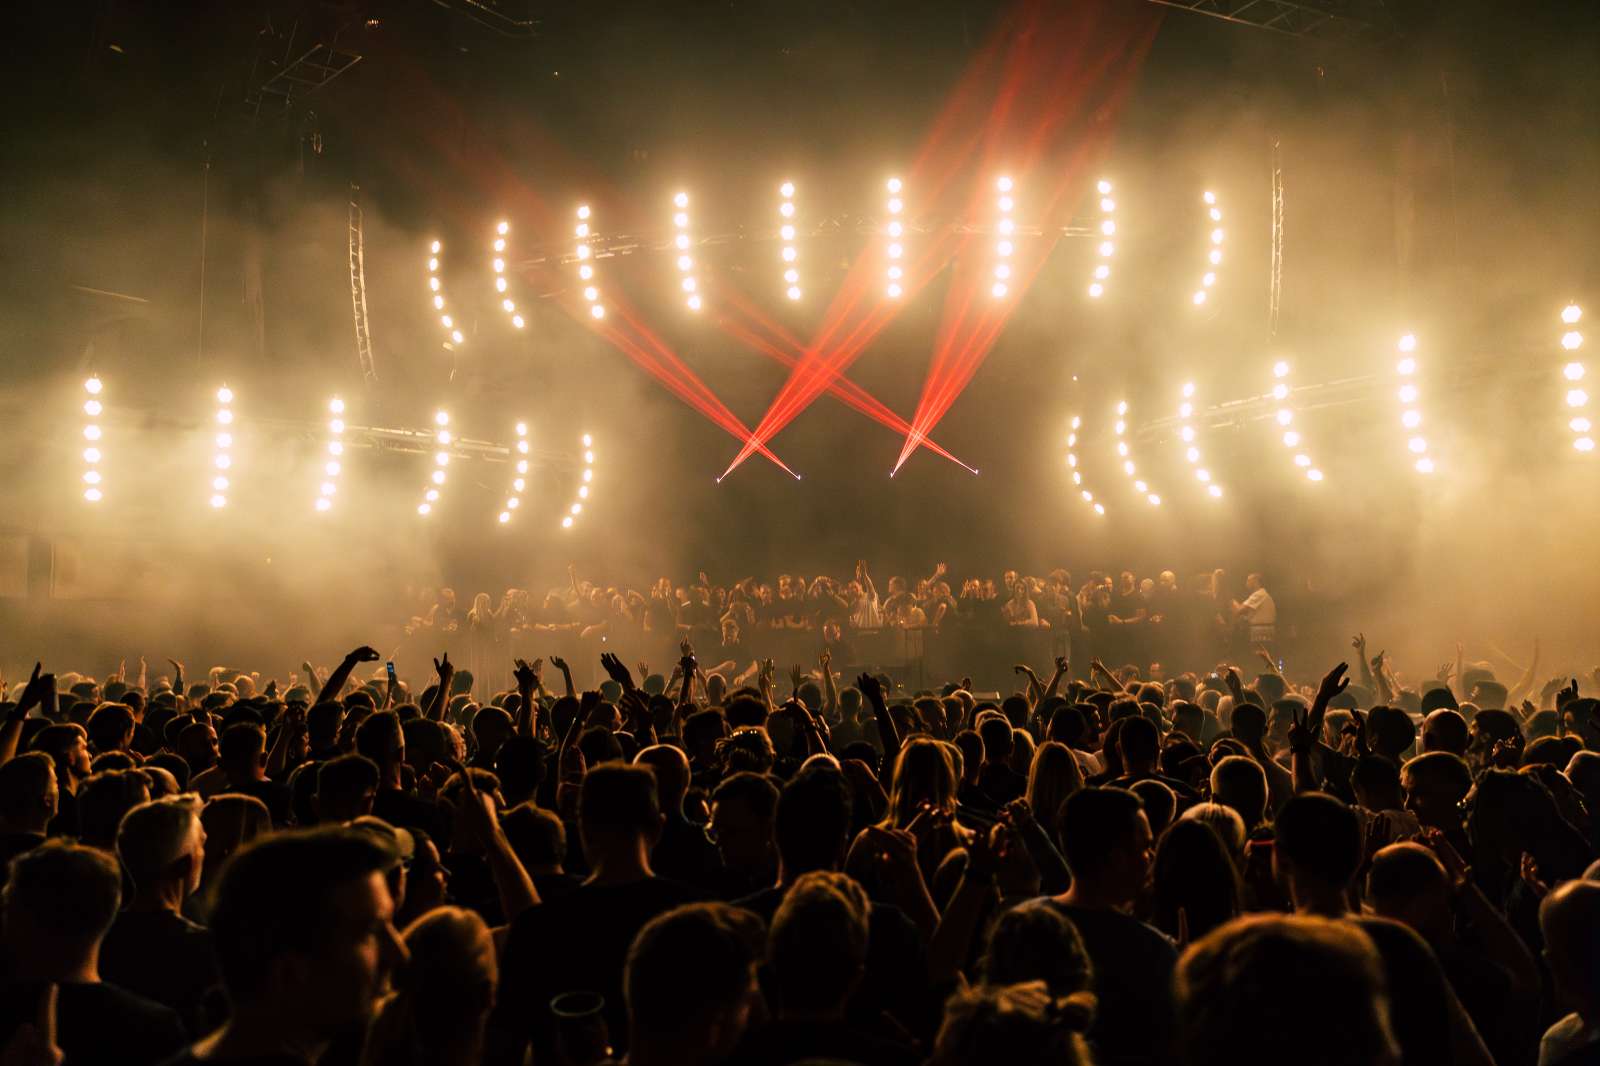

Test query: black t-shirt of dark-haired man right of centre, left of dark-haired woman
[1053,903,1178,1066]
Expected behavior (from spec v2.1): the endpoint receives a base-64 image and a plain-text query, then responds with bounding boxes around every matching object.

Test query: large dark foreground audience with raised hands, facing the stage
[0,627,1600,1066]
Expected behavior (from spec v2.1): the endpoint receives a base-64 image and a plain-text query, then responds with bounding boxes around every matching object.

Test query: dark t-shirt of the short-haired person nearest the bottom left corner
[42,981,189,1066]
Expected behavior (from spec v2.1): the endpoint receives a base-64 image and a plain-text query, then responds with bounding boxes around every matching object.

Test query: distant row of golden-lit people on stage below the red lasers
[405,560,1278,695]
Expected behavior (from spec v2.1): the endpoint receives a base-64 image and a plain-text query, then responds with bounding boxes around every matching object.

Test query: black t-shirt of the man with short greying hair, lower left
[99,911,222,1032]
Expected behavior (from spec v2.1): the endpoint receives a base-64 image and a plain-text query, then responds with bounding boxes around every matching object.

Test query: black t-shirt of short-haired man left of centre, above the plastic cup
[491,877,704,1061]
